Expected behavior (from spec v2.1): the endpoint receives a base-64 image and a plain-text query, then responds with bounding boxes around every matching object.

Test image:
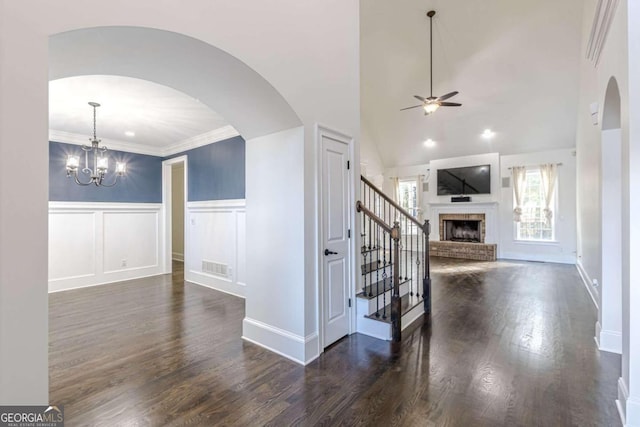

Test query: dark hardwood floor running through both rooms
[49,258,620,426]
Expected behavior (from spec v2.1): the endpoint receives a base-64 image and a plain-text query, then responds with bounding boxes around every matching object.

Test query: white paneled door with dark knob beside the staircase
[321,134,351,347]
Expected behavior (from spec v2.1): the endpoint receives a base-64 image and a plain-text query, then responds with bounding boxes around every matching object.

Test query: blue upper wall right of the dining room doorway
[167,136,245,202]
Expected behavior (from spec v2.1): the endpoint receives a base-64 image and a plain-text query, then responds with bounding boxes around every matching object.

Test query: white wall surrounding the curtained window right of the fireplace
[498,149,576,264]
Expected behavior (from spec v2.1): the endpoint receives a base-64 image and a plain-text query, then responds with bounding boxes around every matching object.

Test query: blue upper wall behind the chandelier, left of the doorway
[49,142,162,203]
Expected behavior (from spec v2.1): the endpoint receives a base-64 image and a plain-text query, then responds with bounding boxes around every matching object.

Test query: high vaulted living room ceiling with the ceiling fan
[360,0,583,167]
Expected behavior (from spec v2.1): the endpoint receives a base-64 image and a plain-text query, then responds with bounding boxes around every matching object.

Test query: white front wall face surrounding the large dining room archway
[0,0,360,404]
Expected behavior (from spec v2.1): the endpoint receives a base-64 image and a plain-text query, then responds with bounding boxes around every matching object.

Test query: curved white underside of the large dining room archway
[49,26,301,139]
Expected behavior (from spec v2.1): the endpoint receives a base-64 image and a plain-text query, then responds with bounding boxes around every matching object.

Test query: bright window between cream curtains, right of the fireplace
[514,169,558,241]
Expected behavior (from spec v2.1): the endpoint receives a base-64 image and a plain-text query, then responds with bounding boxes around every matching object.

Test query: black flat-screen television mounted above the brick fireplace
[438,165,491,196]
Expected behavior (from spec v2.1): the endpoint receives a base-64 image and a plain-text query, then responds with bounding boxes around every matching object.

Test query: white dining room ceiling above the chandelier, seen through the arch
[49,75,229,149]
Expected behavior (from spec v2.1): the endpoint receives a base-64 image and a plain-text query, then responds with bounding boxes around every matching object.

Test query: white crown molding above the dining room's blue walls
[49,125,240,157]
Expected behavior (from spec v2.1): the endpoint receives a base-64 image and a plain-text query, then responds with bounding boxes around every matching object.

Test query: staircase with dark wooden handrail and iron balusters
[356,176,431,341]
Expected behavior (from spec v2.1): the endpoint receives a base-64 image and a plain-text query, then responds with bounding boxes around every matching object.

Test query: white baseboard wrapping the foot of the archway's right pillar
[242,317,319,366]
